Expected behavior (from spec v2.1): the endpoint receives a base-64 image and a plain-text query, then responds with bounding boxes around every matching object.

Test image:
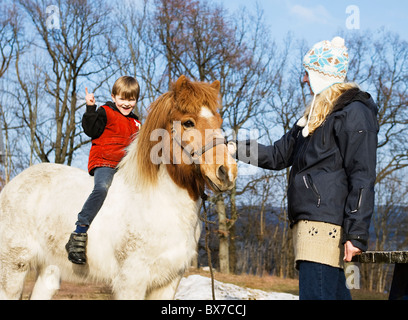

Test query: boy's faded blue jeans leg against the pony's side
[76,167,116,226]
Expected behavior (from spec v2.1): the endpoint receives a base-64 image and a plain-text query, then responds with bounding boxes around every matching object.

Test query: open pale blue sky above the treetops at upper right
[215,0,408,45]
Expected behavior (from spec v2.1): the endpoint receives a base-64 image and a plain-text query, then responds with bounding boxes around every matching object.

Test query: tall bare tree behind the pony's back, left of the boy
[16,0,111,165]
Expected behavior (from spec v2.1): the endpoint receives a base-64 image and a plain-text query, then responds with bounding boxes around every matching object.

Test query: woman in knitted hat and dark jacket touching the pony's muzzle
[237,37,378,299]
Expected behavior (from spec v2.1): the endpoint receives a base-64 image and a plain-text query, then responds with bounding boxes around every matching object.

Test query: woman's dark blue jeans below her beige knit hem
[299,261,351,300]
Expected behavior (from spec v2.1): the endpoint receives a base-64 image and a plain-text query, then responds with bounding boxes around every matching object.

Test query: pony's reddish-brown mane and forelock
[119,76,220,187]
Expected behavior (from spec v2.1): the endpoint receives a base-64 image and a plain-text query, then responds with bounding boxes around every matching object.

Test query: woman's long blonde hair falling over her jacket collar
[303,82,358,134]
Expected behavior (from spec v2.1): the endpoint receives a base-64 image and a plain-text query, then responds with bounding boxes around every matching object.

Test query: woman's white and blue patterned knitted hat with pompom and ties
[298,37,349,137]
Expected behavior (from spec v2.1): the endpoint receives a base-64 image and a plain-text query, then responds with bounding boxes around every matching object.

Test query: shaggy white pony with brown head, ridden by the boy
[0,76,237,299]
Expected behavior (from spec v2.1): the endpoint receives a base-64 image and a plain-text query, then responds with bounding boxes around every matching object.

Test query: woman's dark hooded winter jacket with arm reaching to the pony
[237,88,379,251]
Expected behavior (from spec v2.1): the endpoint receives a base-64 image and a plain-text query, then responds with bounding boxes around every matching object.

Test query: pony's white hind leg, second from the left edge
[30,265,61,300]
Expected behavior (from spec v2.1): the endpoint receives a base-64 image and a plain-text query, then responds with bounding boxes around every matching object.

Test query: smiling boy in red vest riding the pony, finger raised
[65,76,141,264]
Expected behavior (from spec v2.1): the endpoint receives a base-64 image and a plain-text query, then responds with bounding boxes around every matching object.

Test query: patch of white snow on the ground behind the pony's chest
[175,275,299,300]
